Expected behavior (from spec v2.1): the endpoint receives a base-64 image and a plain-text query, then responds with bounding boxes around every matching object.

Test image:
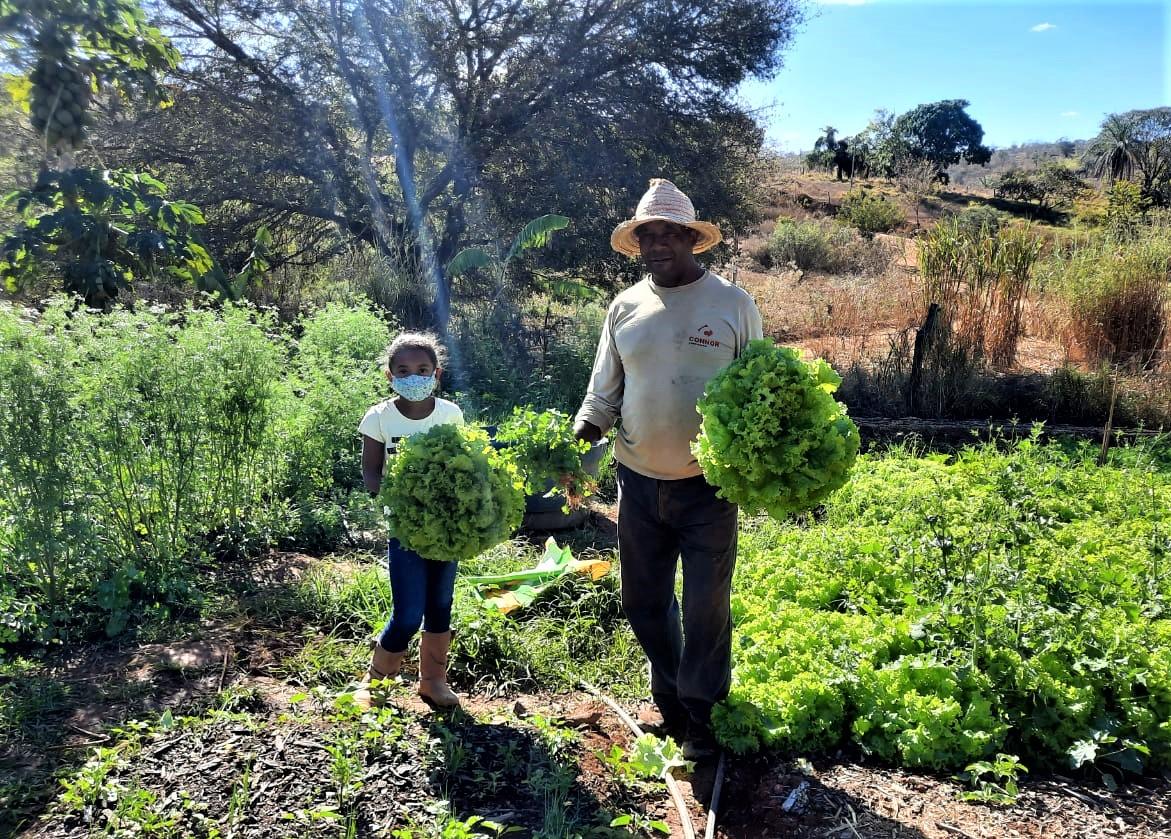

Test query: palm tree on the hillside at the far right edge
[1084,107,1171,205]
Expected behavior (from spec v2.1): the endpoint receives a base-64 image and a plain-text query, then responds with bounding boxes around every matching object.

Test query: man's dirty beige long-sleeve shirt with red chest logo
[577,271,762,480]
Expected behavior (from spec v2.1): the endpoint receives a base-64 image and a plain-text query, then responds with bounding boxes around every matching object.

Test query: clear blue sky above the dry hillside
[740,0,1171,151]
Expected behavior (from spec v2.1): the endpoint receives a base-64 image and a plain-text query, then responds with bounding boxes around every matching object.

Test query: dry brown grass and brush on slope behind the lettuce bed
[728,172,1171,425]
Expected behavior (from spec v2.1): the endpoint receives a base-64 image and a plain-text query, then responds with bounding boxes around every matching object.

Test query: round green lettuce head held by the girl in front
[379,425,525,561]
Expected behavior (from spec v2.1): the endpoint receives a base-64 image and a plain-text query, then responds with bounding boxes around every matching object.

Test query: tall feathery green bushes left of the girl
[0,300,398,643]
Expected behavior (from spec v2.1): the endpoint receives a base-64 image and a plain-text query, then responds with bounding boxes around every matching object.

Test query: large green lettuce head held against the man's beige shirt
[693,339,860,519]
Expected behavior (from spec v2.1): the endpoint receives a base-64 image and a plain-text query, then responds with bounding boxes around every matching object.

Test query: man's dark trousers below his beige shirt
[618,464,737,725]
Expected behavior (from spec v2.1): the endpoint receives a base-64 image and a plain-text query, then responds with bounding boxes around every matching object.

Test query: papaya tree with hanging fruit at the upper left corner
[0,0,227,306]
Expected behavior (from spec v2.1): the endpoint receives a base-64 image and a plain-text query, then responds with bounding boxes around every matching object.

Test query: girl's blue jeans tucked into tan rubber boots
[378,539,459,653]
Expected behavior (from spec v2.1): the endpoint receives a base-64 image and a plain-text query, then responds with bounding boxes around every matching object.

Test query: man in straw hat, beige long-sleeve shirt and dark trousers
[575,179,761,759]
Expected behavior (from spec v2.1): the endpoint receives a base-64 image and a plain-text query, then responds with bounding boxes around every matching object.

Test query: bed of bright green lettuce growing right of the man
[717,438,1171,783]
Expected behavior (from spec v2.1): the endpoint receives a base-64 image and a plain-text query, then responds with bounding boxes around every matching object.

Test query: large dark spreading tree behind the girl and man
[110,0,799,320]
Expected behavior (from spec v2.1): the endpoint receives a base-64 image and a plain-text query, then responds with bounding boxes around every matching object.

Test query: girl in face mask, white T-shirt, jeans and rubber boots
[354,333,464,710]
